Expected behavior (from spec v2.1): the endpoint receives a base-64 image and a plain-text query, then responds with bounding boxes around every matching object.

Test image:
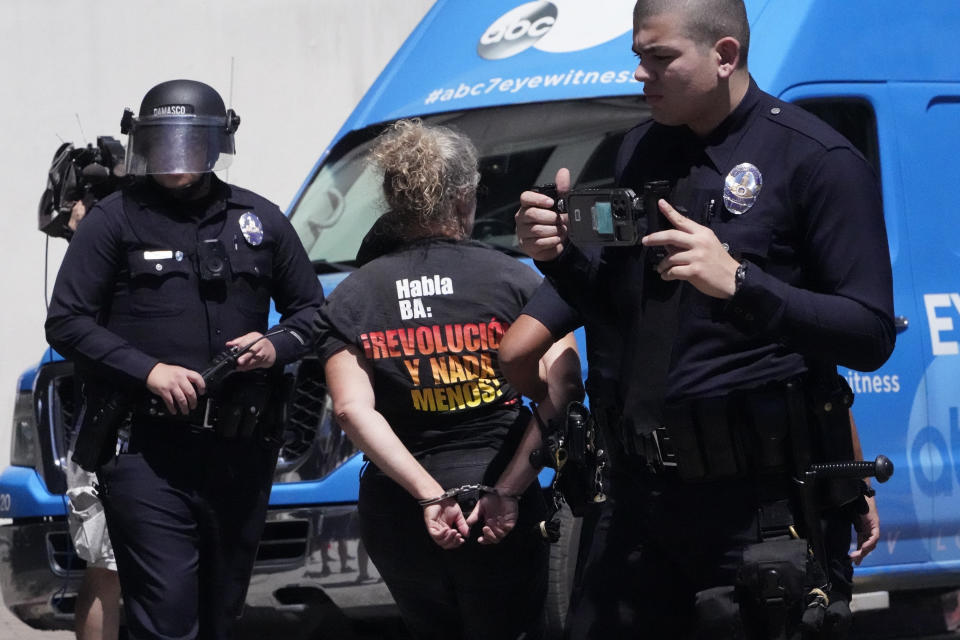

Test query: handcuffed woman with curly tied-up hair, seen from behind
[315,120,580,640]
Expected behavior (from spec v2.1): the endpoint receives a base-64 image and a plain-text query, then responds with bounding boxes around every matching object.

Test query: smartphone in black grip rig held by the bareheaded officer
[533,180,671,247]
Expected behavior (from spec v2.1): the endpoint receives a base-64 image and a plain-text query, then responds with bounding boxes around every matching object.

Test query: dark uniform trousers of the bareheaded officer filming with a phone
[566,464,853,639]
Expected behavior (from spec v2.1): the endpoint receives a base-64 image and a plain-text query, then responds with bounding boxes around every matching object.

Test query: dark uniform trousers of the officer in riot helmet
[98,422,277,640]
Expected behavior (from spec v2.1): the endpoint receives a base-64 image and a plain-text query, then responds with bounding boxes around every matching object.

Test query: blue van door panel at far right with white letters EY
[889,82,960,572]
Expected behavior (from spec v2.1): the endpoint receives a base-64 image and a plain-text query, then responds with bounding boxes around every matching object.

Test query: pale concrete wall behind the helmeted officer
[0,0,433,468]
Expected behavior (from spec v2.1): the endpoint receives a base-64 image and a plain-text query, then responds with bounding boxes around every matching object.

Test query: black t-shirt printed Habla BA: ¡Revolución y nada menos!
[316,239,540,455]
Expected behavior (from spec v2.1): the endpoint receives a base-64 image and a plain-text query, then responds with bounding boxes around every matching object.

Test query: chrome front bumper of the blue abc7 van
[0,504,395,629]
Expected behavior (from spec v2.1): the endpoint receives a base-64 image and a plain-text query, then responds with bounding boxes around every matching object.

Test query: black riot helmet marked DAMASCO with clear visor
[120,80,240,176]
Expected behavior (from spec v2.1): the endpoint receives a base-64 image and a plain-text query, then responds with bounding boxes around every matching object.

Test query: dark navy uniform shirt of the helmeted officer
[46,175,323,388]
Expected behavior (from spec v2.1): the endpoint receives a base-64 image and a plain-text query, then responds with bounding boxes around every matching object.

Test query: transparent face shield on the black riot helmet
[126,115,235,176]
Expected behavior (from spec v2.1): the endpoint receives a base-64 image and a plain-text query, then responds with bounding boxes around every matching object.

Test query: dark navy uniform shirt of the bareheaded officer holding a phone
[538,79,895,400]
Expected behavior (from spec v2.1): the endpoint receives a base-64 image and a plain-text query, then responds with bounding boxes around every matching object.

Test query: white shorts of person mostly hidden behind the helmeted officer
[66,452,117,571]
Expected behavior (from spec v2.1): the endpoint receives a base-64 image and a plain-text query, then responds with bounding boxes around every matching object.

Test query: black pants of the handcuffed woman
[359,449,548,640]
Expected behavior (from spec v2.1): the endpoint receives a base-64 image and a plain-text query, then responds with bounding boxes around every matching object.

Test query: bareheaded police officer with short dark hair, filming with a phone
[517,0,895,638]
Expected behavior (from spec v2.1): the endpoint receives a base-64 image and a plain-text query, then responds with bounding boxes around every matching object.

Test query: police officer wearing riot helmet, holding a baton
[46,80,323,638]
